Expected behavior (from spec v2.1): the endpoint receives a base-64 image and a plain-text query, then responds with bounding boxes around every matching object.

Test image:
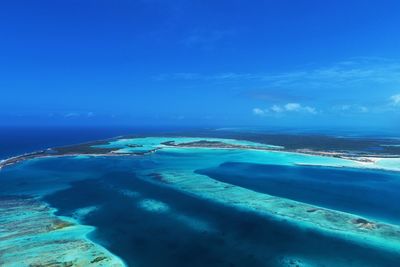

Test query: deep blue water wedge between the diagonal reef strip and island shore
[197,162,400,223]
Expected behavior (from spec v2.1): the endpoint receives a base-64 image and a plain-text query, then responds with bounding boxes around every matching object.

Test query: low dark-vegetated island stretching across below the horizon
[0,130,400,169]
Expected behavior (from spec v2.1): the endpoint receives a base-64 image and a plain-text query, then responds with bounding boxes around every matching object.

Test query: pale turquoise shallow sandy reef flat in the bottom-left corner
[0,196,125,267]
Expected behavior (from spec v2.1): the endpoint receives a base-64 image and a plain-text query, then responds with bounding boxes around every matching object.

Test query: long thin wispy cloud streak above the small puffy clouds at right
[155,58,400,88]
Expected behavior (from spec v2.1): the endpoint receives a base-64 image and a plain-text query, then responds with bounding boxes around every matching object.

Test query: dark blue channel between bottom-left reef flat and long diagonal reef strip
[0,158,400,267]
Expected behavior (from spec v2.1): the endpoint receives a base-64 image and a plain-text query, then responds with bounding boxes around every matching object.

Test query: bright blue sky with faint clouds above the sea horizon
[0,0,400,130]
